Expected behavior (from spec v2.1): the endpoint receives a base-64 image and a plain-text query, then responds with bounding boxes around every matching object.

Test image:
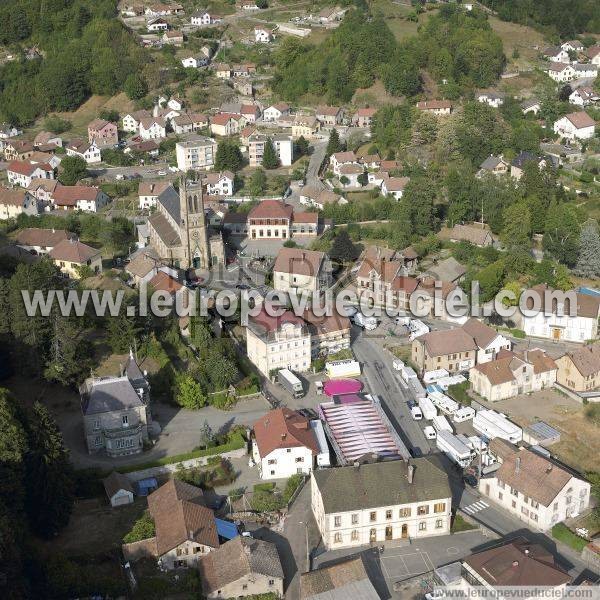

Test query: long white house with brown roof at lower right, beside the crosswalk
[479,439,590,531]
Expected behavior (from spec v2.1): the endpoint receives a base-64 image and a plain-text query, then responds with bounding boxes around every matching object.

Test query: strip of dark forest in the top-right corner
[482,0,600,38]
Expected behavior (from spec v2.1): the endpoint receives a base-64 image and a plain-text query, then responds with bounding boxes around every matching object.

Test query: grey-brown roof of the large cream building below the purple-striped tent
[313,458,452,513]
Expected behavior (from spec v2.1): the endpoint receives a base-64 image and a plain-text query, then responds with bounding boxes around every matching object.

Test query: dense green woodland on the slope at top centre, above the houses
[273,5,505,103]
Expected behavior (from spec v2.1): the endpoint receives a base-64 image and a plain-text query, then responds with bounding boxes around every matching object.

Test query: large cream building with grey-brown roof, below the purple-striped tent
[311,458,452,550]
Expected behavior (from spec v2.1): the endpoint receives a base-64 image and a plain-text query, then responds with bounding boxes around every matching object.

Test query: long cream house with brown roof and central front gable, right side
[469,348,557,402]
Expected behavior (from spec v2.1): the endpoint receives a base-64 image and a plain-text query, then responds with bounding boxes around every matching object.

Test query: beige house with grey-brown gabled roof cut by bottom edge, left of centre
[198,536,283,598]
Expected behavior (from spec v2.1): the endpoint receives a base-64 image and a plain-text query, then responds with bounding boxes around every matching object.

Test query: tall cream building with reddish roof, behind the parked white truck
[246,310,311,377]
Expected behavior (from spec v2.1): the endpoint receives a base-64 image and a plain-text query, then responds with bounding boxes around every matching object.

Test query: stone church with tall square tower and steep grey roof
[148,177,225,269]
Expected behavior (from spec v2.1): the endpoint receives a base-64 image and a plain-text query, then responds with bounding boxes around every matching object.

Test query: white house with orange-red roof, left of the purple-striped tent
[252,408,319,479]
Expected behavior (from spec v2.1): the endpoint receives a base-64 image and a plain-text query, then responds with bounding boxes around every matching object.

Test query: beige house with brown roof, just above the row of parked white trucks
[412,328,477,373]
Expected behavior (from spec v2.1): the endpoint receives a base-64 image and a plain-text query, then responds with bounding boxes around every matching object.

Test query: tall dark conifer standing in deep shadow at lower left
[26,402,74,538]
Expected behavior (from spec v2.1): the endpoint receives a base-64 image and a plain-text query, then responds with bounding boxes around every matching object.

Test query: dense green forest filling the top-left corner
[0,0,147,125]
